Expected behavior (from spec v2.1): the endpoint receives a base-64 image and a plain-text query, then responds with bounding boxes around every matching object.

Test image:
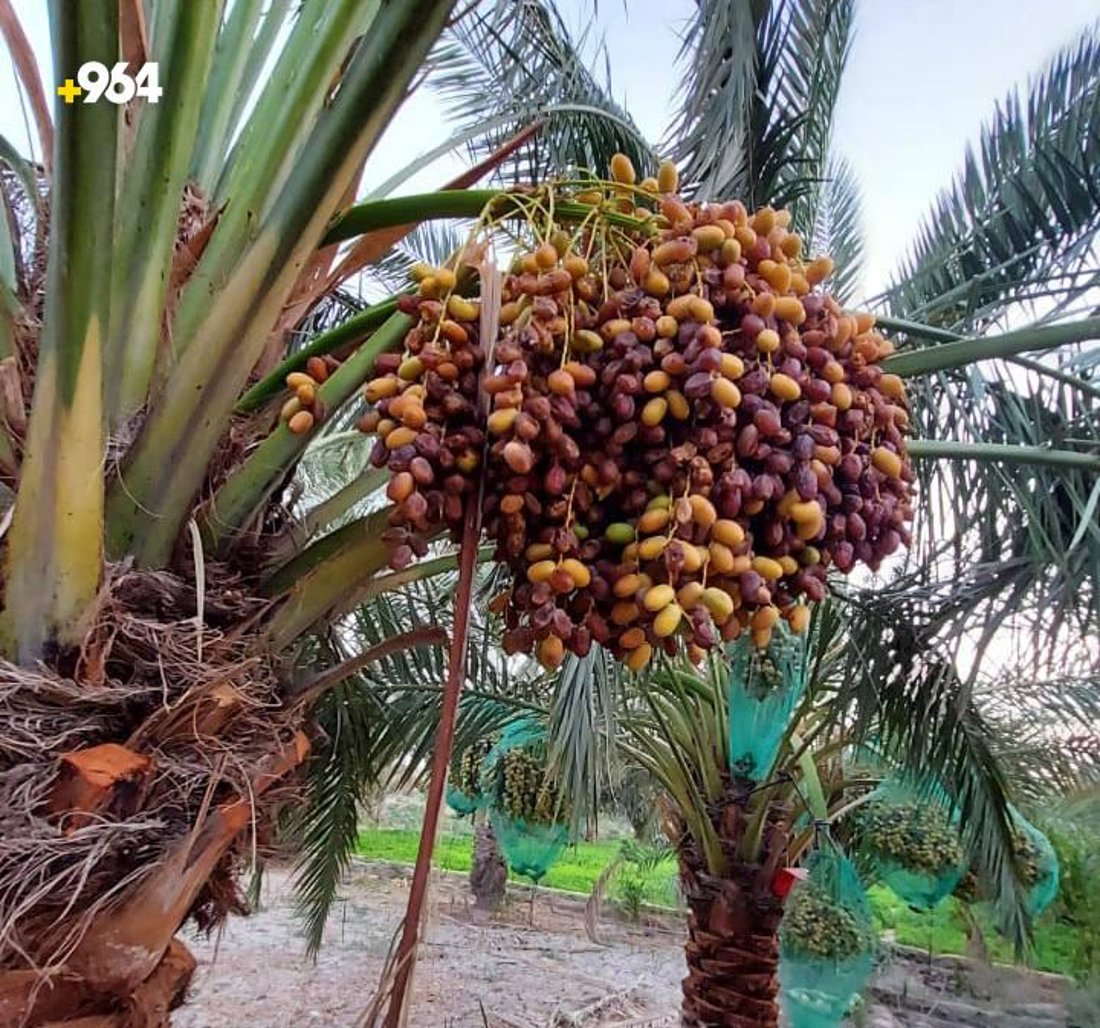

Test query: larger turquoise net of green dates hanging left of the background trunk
[482,718,569,884]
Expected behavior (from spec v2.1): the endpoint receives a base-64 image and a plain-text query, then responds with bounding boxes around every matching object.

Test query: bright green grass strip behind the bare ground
[359,823,1075,973]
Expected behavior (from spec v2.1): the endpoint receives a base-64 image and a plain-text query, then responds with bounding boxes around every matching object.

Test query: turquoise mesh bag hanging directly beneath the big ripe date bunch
[726,623,806,782]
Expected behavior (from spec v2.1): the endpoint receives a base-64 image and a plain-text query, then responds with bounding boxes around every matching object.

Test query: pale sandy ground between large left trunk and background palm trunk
[174,867,683,1028]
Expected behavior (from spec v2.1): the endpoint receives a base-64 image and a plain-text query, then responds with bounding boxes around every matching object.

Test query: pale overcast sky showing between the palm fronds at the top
[0,0,1100,294]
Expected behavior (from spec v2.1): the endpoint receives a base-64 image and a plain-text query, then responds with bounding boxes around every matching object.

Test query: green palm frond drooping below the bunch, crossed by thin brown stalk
[286,574,549,953]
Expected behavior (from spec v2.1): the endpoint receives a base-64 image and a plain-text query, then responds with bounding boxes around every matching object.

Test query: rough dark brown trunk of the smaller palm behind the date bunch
[679,789,787,1028]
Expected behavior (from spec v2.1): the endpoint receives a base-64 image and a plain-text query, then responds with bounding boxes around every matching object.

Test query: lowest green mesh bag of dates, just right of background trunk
[779,842,876,1028]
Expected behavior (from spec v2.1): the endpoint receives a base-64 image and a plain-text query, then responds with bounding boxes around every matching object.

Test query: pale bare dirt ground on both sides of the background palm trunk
[174,865,1066,1028]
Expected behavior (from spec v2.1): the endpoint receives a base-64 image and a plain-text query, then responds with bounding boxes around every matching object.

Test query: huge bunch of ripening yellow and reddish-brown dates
[360,158,914,671]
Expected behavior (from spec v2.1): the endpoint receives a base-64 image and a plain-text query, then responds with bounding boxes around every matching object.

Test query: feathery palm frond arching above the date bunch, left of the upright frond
[429,0,656,183]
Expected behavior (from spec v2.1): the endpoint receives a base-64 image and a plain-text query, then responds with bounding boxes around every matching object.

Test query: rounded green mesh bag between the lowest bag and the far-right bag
[853,781,966,910]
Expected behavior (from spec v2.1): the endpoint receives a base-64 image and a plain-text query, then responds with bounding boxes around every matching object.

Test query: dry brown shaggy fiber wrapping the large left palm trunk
[0,566,303,985]
